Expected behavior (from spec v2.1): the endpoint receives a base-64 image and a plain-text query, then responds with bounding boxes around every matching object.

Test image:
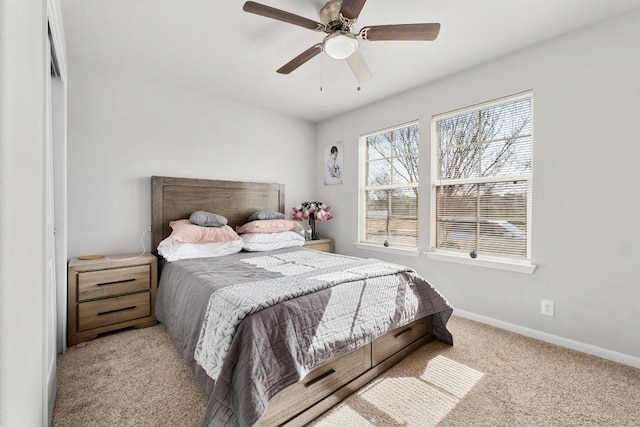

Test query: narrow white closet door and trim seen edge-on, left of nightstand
[42,0,67,426]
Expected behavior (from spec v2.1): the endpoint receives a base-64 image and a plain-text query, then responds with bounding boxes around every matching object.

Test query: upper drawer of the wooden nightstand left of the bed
[78,265,151,301]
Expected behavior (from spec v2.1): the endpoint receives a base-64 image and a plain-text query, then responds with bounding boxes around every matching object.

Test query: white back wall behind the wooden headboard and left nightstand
[68,58,315,258]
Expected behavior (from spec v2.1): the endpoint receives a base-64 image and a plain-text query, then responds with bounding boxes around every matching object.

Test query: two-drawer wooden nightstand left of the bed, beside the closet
[67,253,158,346]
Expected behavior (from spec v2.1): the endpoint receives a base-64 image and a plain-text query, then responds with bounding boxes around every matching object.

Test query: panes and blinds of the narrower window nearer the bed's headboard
[359,122,419,248]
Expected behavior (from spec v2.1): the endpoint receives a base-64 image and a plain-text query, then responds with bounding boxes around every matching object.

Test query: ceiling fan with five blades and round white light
[242,0,440,82]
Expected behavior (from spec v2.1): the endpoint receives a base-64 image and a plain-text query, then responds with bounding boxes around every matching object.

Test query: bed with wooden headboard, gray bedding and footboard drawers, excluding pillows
[151,176,453,426]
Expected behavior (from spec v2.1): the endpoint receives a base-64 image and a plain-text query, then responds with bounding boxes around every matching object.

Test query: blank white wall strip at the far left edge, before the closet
[0,0,48,426]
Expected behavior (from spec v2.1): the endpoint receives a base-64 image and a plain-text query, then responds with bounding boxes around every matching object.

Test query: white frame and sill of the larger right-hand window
[425,90,536,274]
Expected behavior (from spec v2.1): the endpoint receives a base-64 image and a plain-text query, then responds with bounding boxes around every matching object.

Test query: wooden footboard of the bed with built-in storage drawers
[256,316,433,427]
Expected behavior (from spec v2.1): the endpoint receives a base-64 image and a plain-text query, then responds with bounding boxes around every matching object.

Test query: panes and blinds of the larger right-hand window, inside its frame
[431,93,533,260]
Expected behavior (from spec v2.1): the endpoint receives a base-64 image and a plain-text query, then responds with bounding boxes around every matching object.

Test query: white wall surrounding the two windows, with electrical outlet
[316,12,640,366]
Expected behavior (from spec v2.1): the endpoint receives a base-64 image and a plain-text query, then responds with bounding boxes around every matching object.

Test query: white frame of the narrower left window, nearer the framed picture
[355,119,421,251]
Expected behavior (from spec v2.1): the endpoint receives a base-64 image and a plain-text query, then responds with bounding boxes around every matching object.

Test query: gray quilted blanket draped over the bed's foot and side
[156,248,452,426]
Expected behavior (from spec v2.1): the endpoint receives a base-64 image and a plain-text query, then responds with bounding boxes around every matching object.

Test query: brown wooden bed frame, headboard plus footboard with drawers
[151,176,433,426]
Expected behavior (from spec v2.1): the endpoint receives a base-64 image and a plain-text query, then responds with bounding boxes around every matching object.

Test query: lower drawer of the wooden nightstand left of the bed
[78,292,151,331]
